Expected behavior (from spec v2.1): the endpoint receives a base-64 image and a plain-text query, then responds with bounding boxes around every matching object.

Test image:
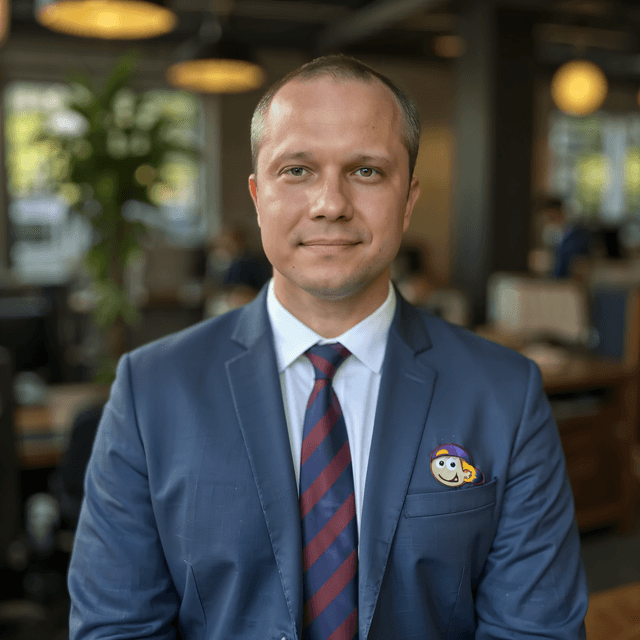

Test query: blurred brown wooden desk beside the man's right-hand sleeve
[478,328,640,532]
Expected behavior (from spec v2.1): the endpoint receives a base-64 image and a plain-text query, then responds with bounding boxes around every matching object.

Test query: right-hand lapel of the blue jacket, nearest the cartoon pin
[358,294,436,638]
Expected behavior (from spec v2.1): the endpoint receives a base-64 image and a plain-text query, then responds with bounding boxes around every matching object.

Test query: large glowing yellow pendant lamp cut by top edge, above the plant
[36,0,178,40]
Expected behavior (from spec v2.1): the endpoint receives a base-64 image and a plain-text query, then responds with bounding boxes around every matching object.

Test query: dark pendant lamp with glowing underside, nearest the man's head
[166,15,266,93]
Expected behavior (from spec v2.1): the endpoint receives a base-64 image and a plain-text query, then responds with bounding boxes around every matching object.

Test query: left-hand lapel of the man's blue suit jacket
[226,287,302,637]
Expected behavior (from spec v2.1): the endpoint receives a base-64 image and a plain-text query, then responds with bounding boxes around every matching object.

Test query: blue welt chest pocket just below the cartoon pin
[404,480,497,518]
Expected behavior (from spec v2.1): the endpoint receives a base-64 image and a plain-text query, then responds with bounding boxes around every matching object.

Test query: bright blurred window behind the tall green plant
[5,82,205,284]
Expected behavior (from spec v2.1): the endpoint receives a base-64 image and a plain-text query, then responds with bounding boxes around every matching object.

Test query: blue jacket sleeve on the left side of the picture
[68,356,179,640]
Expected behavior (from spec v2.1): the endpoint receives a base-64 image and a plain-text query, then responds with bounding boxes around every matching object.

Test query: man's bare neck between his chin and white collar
[273,271,389,339]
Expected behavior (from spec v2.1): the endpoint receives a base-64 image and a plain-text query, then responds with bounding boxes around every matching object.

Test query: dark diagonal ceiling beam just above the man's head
[316,0,442,52]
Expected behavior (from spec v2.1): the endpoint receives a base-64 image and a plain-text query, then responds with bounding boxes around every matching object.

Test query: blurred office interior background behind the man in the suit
[0,0,640,640]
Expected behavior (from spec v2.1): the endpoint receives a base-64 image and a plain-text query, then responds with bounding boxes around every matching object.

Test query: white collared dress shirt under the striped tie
[267,280,396,536]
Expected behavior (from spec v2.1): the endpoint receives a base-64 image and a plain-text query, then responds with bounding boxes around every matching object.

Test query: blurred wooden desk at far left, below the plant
[14,383,109,469]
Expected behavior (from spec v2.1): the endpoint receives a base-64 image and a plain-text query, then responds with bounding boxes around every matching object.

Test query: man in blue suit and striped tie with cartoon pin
[69,56,587,640]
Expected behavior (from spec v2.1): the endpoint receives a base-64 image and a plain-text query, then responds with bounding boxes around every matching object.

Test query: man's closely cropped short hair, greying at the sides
[251,54,420,179]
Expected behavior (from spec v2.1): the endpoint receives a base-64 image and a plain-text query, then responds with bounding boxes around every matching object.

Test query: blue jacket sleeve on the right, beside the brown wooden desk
[476,362,588,640]
